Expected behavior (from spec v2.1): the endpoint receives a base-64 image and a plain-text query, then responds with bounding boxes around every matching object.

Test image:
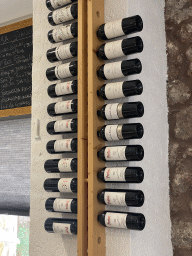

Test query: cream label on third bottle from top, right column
[103,61,124,80]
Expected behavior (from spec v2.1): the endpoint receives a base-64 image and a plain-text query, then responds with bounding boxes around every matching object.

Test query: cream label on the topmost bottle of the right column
[104,20,125,39]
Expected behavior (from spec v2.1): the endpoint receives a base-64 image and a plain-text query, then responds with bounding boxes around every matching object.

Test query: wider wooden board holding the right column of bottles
[87,0,105,256]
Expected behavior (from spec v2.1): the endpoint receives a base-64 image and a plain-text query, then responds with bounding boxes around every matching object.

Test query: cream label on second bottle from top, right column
[104,40,125,60]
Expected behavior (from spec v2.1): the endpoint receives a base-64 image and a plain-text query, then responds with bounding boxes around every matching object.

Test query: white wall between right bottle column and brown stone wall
[105,0,173,256]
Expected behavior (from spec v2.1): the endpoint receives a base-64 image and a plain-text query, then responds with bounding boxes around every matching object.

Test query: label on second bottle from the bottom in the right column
[104,192,127,206]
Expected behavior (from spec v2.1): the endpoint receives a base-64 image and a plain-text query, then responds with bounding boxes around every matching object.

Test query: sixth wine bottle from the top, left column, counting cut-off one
[47,80,77,98]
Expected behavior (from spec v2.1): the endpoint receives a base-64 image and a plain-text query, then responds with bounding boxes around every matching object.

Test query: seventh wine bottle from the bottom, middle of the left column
[47,99,77,116]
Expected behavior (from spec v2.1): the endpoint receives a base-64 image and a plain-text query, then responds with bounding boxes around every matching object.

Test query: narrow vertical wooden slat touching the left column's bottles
[77,0,88,256]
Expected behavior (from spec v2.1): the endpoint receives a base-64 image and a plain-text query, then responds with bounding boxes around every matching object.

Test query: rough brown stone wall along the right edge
[165,0,192,256]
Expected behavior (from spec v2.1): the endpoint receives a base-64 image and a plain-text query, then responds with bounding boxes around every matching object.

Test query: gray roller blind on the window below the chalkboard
[0,118,31,215]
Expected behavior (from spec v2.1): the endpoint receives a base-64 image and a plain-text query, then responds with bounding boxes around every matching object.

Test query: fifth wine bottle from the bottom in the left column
[47,138,77,154]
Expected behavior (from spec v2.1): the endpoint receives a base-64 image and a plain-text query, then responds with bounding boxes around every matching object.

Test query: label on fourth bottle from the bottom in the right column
[105,146,127,161]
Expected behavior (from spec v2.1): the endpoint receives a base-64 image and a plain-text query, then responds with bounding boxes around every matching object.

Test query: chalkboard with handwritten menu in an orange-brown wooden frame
[0,19,32,117]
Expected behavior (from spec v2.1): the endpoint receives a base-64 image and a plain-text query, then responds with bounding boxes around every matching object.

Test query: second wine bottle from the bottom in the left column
[45,198,77,213]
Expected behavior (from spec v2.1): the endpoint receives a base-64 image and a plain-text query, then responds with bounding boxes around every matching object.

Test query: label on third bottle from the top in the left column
[52,24,73,43]
